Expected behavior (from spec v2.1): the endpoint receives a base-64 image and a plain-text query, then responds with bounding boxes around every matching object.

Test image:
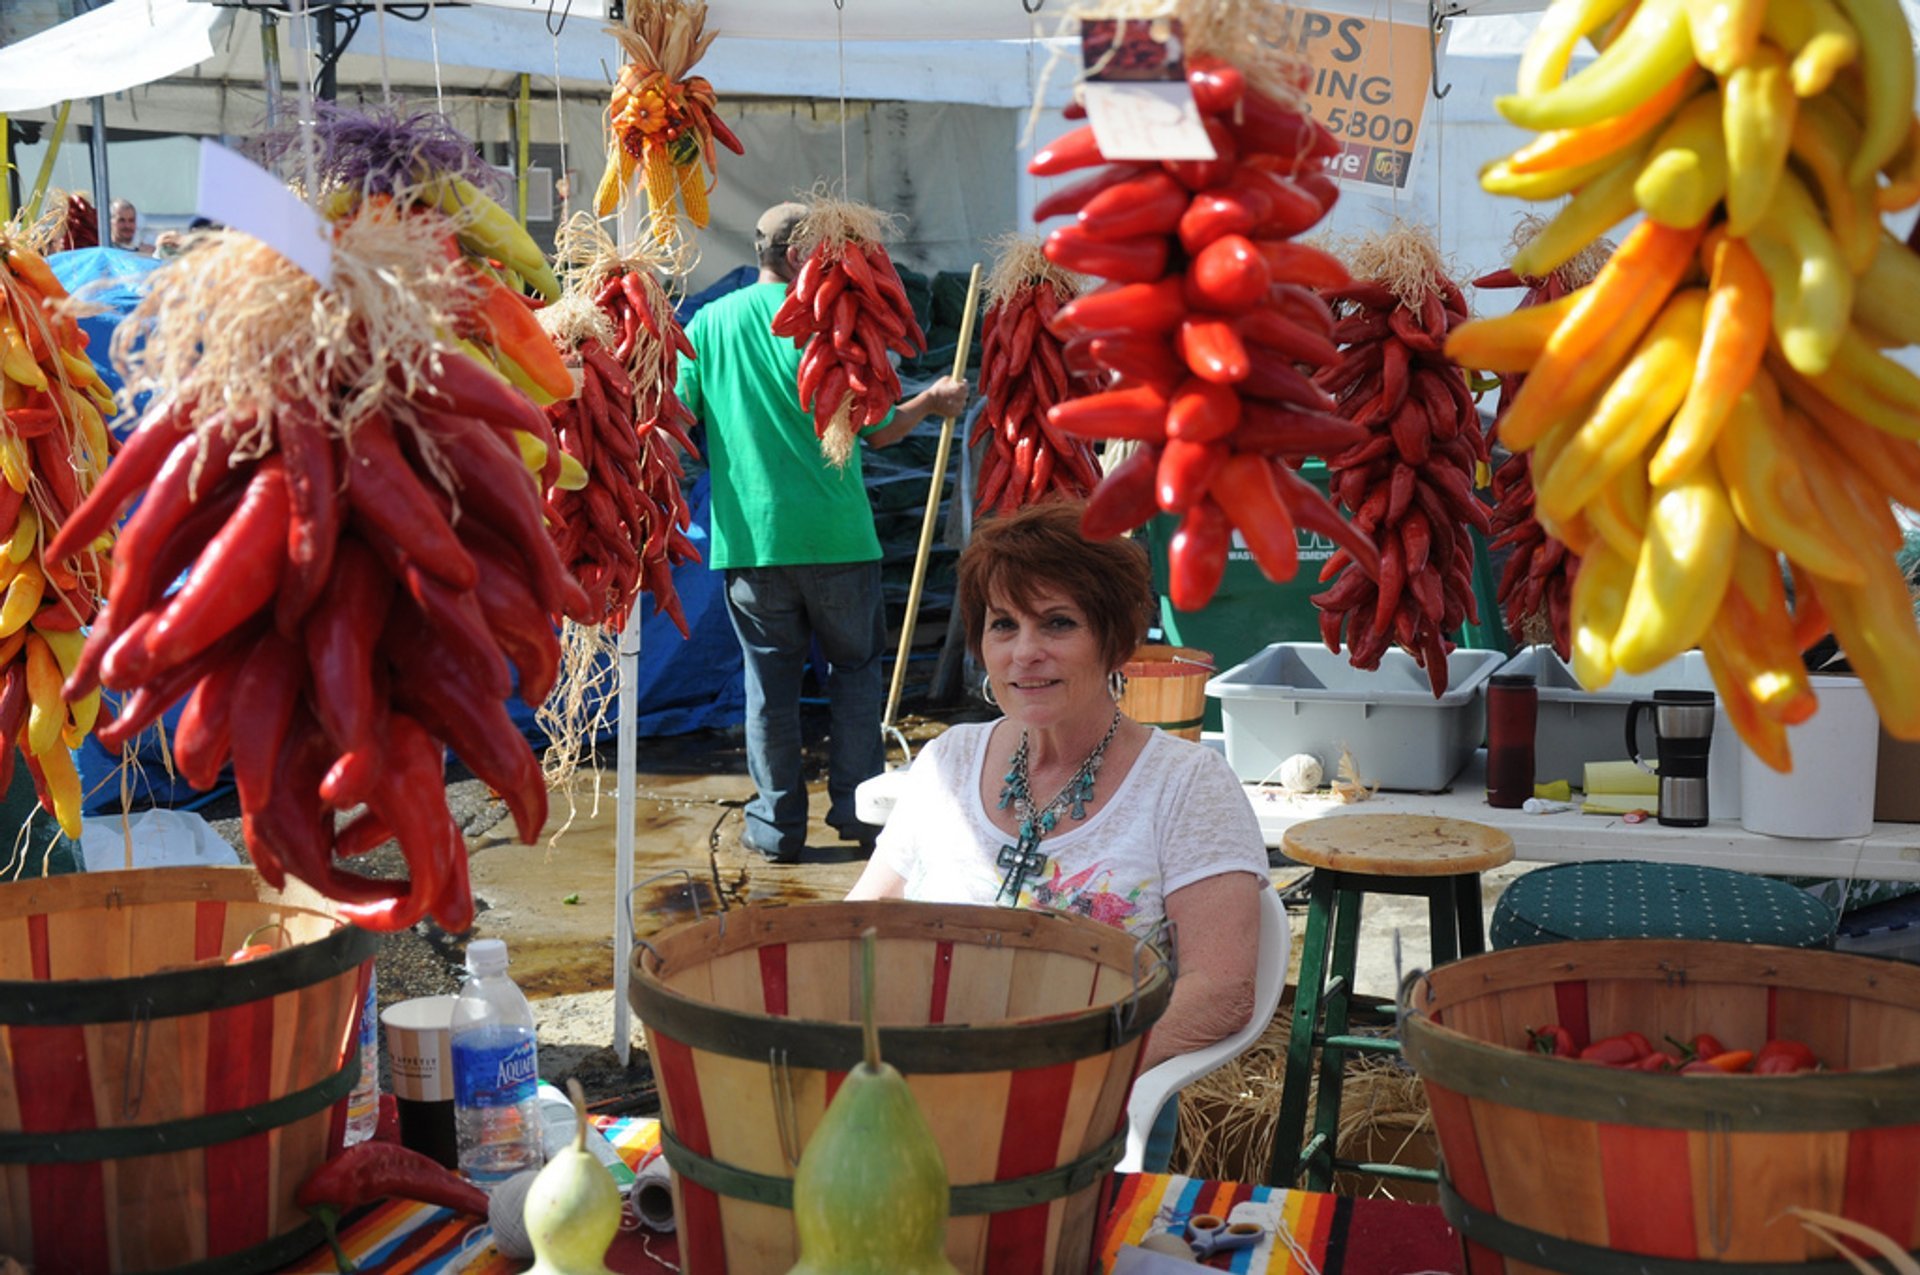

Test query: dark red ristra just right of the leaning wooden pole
[968,236,1100,513]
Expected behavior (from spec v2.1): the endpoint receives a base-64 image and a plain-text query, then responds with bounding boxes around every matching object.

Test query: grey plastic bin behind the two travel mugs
[1496,647,1741,820]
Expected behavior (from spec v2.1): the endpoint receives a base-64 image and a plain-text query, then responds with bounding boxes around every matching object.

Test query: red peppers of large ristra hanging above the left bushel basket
[48,353,588,931]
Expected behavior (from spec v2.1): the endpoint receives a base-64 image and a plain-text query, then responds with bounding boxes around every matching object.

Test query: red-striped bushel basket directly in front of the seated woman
[630,901,1173,1275]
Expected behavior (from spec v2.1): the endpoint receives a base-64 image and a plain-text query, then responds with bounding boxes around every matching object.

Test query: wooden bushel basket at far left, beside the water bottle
[0,868,378,1273]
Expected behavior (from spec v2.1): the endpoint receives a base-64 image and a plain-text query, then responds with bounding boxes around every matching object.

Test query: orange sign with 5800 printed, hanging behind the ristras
[1292,6,1444,196]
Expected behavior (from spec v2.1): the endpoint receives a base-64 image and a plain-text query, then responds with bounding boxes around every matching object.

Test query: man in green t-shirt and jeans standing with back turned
[680,204,968,862]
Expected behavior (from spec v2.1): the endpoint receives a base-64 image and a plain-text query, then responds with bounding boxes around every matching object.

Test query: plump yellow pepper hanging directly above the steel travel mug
[1620,467,1740,674]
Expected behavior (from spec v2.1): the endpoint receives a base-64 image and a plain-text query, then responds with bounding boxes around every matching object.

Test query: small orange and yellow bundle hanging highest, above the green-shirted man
[593,0,747,246]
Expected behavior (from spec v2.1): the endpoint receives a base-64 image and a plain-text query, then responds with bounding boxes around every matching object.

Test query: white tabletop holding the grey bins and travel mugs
[1246,751,1920,881]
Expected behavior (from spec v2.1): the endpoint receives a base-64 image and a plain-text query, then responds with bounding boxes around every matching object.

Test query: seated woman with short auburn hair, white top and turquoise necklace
[847,501,1271,1075]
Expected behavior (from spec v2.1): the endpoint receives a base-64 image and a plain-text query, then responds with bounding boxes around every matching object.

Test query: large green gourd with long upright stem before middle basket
[787,929,960,1275]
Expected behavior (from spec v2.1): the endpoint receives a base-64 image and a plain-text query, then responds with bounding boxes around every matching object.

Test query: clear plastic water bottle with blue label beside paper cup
[449,939,545,1187]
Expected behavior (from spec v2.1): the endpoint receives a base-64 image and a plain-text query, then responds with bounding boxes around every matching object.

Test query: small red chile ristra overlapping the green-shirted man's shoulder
[774,192,927,465]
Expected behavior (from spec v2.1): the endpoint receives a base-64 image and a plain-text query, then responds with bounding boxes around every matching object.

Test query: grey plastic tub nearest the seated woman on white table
[1206,641,1505,791]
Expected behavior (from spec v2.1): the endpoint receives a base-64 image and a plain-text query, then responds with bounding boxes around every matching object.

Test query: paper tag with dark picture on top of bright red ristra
[1079,17,1213,159]
